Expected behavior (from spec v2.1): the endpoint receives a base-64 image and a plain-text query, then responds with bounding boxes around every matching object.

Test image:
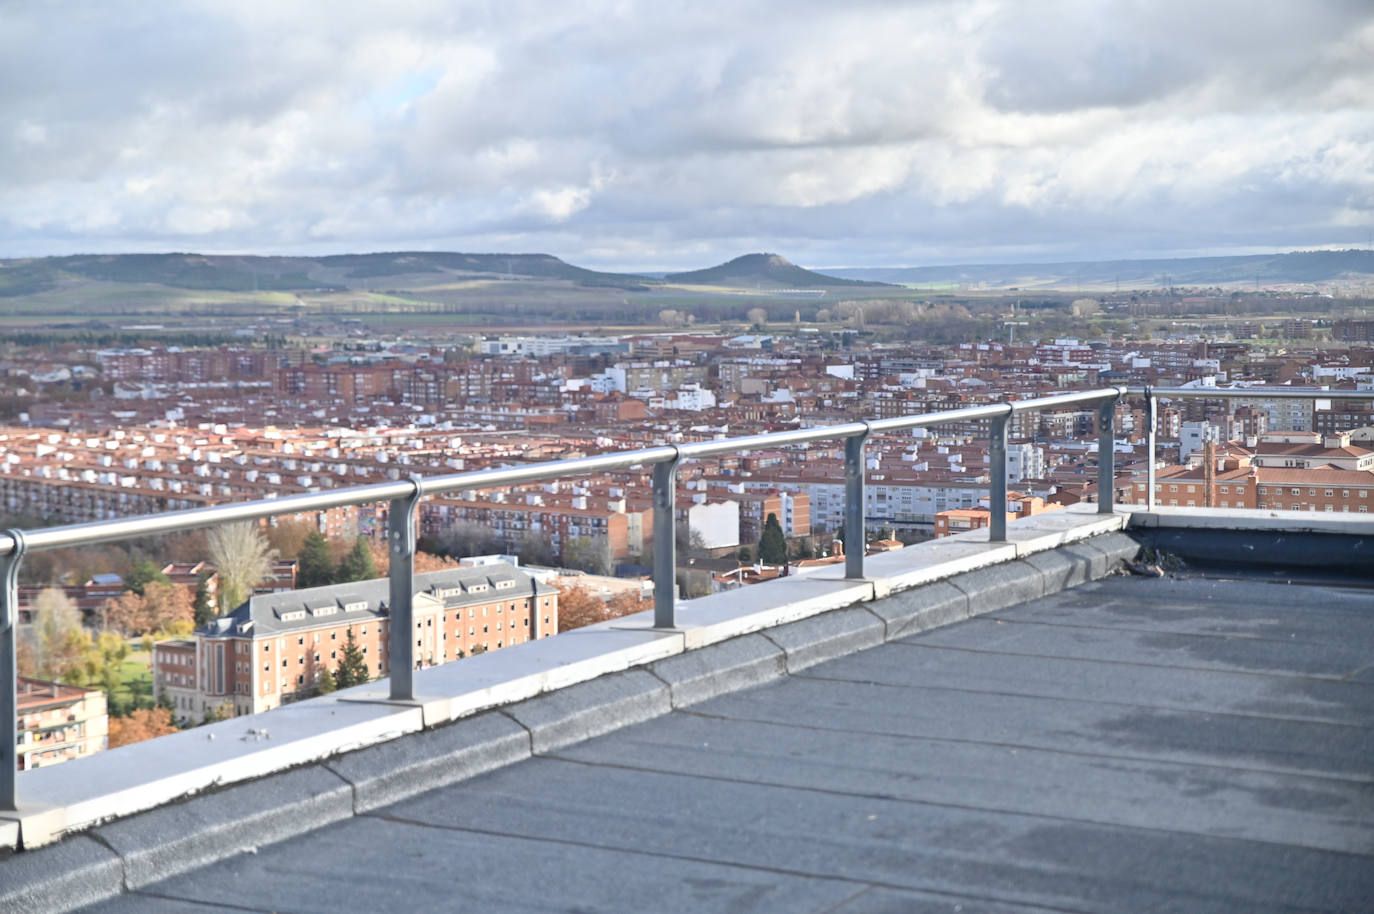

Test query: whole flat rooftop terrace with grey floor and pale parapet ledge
[0,387,1374,911]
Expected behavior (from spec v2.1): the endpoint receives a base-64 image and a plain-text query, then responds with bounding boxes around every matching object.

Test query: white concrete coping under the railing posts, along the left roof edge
[0,506,1148,848]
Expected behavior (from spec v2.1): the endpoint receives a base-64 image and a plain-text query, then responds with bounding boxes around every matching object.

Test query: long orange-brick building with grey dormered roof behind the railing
[153,562,558,722]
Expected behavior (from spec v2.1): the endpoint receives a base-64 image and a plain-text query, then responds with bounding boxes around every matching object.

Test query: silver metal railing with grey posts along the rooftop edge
[0,386,1374,811]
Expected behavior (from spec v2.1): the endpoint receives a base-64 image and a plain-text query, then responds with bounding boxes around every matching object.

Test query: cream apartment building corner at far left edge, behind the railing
[16,676,110,771]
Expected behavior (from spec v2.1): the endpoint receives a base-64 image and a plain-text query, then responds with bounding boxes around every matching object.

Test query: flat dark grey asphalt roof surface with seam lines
[88,576,1374,914]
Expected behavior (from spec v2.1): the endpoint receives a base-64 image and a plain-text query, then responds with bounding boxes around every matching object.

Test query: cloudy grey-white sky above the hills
[0,0,1374,269]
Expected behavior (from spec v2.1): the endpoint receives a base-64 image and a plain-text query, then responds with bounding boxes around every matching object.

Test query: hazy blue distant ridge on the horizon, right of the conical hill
[829,250,1374,287]
